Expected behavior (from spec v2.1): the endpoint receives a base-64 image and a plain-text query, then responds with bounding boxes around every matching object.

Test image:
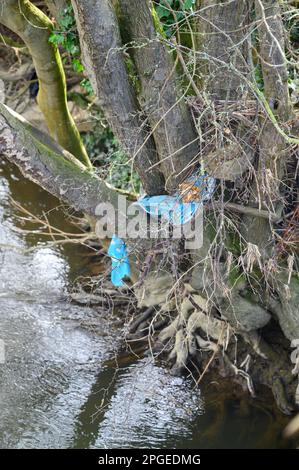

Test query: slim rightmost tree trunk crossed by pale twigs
[244,0,292,250]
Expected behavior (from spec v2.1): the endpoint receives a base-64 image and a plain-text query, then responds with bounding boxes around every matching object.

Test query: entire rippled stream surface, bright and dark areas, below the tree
[0,163,292,449]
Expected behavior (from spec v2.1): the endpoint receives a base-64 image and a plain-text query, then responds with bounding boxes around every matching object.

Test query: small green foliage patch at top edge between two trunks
[155,0,195,37]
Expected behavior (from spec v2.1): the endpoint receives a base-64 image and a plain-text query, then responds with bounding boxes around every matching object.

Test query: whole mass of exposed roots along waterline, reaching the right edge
[68,276,299,414]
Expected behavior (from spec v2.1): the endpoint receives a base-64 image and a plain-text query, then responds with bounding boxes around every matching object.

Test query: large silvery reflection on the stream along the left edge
[0,165,115,448]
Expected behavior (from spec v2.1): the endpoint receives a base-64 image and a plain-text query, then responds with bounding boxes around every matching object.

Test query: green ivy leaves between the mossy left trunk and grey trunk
[49,5,93,95]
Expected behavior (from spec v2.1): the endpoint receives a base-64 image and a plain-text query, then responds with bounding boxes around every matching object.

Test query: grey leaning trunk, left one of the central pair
[72,0,164,195]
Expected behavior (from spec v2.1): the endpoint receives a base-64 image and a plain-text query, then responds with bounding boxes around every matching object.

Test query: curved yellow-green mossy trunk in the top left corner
[0,0,91,167]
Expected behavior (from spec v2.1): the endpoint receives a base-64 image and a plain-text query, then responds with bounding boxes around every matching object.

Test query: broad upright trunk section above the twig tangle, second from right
[198,0,252,100]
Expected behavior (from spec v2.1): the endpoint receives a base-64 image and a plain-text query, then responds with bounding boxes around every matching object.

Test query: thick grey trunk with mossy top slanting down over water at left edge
[0,103,118,216]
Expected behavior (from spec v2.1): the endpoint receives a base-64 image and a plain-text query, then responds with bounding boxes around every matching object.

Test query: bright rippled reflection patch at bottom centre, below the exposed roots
[95,359,203,448]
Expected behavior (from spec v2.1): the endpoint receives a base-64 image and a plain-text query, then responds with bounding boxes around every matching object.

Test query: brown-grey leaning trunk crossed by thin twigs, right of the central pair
[119,0,198,191]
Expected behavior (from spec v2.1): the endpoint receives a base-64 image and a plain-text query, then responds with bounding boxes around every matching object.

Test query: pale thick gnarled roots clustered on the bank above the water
[128,289,258,396]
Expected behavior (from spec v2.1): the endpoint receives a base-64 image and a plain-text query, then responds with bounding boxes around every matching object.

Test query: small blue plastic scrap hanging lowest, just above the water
[108,234,131,287]
